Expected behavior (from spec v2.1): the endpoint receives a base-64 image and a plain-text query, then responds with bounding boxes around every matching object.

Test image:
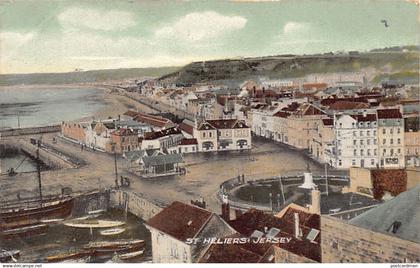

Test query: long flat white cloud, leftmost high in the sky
[58,7,136,31]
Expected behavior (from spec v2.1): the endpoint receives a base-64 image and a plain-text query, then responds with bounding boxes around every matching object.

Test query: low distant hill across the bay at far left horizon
[0,67,180,86]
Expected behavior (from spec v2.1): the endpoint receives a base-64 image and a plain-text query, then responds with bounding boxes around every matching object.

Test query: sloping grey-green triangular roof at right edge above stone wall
[349,184,420,243]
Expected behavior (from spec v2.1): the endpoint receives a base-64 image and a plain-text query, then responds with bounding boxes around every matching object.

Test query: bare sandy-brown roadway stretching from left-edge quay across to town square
[0,134,322,212]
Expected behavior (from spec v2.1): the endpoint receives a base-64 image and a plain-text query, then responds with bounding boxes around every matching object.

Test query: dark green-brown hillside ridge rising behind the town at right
[160,46,419,85]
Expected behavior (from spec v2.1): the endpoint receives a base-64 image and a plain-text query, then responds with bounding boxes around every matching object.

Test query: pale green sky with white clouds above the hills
[0,0,419,74]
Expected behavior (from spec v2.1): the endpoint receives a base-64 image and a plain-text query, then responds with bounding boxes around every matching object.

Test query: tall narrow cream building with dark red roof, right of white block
[377,108,405,168]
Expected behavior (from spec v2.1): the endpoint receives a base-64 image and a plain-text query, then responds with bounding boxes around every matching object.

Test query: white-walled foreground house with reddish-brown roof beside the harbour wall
[145,202,235,263]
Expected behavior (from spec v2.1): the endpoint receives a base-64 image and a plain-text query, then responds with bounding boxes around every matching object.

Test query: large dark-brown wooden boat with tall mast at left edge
[0,142,73,230]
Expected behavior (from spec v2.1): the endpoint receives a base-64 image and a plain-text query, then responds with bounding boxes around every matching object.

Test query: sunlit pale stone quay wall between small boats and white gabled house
[110,190,166,221]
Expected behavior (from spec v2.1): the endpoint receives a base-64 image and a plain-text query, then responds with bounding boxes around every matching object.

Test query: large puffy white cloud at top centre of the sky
[155,11,247,42]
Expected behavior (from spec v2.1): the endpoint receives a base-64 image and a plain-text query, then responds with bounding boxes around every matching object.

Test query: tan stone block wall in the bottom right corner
[321,216,420,263]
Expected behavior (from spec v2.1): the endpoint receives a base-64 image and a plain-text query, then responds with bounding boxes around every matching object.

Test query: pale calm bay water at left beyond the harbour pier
[0,86,104,128]
